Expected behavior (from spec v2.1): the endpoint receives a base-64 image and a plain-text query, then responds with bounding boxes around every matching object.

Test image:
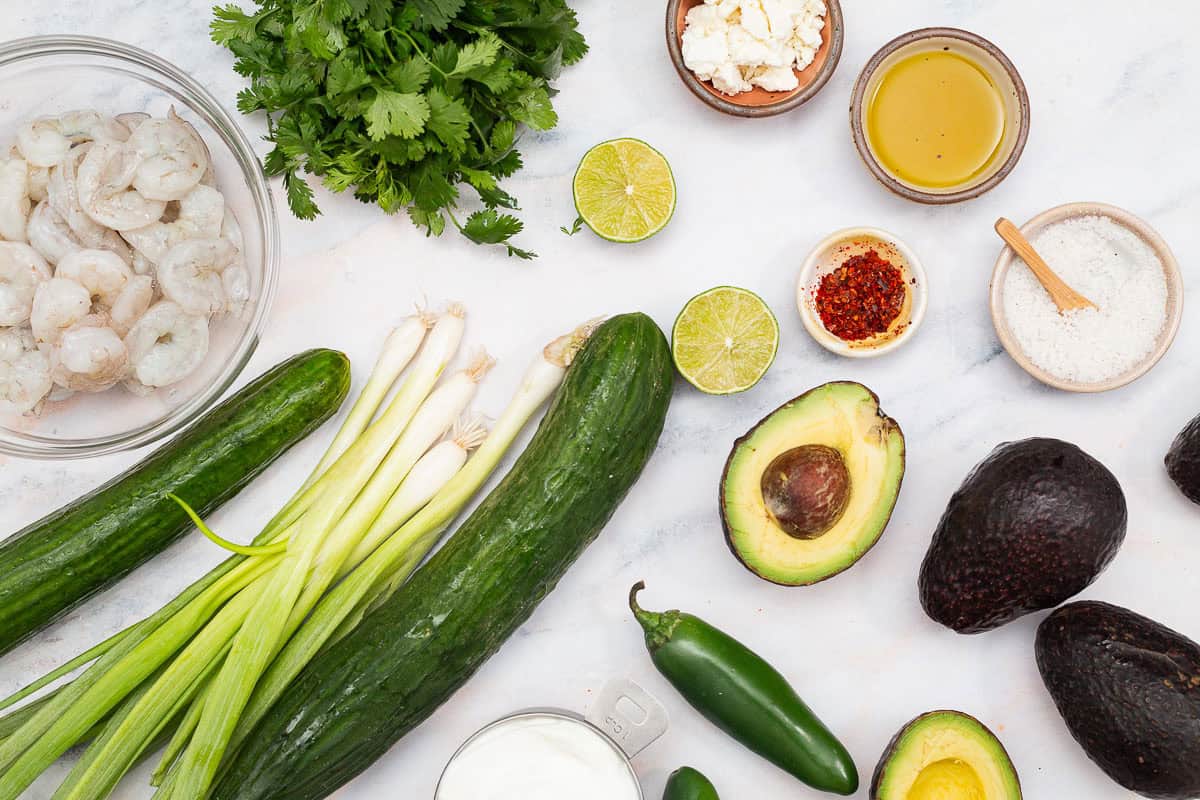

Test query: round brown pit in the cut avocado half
[761,444,850,539]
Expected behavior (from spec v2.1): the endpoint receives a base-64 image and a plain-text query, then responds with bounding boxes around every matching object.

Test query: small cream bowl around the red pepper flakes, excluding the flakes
[796,228,929,359]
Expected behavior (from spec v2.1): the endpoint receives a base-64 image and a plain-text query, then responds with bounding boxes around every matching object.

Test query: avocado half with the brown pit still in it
[720,381,905,587]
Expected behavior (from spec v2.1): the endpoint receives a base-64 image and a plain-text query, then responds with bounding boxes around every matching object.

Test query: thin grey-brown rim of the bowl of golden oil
[850,28,1030,205]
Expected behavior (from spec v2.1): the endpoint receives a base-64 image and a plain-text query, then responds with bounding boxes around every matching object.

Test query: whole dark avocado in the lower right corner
[1034,602,1200,800]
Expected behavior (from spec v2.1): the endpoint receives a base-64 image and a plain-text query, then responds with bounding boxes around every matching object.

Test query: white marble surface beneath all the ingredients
[0,0,1200,800]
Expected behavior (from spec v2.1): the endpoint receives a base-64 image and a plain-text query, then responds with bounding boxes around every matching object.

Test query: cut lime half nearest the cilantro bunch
[574,139,676,242]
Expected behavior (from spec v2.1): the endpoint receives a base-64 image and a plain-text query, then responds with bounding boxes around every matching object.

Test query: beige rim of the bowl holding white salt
[990,203,1183,392]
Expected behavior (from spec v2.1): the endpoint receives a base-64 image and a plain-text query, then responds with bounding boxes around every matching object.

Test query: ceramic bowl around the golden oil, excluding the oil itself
[850,28,1030,205]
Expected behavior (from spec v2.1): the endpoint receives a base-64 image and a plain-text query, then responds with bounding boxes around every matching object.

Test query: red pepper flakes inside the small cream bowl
[816,249,907,342]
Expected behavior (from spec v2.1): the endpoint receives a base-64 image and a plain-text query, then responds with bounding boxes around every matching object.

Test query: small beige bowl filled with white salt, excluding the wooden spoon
[989,203,1183,392]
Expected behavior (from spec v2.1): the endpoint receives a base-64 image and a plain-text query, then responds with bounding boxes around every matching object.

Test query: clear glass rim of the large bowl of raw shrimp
[0,36,280,458]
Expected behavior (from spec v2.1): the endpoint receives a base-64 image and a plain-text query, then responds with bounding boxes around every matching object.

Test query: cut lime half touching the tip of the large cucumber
[671,287,779,395]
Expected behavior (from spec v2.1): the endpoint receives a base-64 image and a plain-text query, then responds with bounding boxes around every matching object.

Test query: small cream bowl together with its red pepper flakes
[796,228,928,359]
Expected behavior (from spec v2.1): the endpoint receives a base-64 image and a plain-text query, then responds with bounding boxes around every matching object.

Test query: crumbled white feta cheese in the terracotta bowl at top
[683,0,826,95]
